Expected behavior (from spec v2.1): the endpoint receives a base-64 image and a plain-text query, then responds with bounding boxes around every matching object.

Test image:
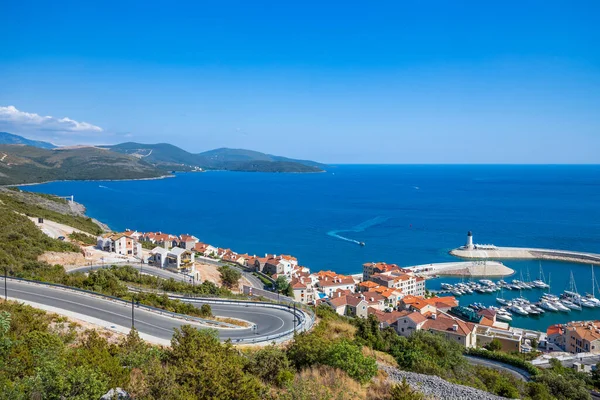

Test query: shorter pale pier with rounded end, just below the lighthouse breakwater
[405,261,515,278]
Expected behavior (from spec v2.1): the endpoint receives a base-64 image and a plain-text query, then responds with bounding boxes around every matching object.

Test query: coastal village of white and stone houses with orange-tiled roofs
[89,230,600,369]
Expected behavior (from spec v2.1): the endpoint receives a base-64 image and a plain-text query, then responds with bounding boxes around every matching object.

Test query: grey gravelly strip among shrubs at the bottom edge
[380,365,504,400]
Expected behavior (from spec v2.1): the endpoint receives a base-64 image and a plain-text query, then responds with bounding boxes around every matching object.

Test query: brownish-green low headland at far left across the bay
[0,144,165,185]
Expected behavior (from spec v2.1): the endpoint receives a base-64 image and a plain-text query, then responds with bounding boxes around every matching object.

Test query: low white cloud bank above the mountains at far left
[0,106,103,132]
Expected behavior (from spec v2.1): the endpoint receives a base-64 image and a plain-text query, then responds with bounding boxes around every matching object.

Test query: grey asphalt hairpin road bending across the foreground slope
[0,279,294,342]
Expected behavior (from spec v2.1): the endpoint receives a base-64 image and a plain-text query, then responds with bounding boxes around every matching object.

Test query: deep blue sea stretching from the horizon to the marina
[23,165,600,329]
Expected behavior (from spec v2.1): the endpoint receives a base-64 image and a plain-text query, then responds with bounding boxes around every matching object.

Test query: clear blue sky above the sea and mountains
[0,0,600,163]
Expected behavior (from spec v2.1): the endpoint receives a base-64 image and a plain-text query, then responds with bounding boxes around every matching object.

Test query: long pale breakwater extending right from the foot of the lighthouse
[450,245,600,264]
